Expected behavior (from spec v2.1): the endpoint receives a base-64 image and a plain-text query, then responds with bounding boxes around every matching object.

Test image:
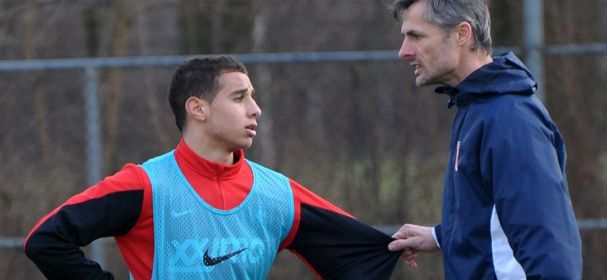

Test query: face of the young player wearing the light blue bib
[204,72,261,151]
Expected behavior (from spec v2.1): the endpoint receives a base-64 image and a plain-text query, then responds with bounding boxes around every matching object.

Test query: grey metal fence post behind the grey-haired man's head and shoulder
[523,0,546,102]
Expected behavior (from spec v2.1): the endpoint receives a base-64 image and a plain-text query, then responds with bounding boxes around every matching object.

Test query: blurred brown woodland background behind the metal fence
[0,0,607,279]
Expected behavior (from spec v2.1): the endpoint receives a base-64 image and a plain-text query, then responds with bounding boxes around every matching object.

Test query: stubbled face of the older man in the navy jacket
[398,1,459,86]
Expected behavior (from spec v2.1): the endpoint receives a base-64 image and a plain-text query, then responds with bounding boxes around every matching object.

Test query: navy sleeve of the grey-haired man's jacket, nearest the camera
[481,98,582,279]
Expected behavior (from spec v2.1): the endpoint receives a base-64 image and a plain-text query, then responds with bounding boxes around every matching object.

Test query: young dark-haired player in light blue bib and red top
[24,56,400,279]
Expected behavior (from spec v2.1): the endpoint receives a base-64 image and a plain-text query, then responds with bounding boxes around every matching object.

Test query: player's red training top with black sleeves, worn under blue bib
[24,140,399,279]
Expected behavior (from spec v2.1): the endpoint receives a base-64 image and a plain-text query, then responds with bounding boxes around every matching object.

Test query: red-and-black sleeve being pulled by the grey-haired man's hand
[288,180,401,279]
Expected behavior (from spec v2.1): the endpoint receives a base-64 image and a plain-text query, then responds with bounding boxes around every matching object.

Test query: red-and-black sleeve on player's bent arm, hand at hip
[23,165,148,279]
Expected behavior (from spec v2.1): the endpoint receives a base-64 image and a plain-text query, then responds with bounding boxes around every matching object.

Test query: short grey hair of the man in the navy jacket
[392,0,493,55]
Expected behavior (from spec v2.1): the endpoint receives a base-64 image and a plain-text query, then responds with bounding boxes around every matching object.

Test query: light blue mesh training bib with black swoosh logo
[141,152,294,280]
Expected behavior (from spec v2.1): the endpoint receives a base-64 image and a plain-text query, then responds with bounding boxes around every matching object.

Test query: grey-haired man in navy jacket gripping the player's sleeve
[389,0,582,279]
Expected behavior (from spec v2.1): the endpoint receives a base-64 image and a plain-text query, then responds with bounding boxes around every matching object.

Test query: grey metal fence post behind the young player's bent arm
[84,66,104,267]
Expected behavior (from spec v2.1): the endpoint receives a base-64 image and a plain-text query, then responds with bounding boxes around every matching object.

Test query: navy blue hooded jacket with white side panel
[434,53,582,279]
